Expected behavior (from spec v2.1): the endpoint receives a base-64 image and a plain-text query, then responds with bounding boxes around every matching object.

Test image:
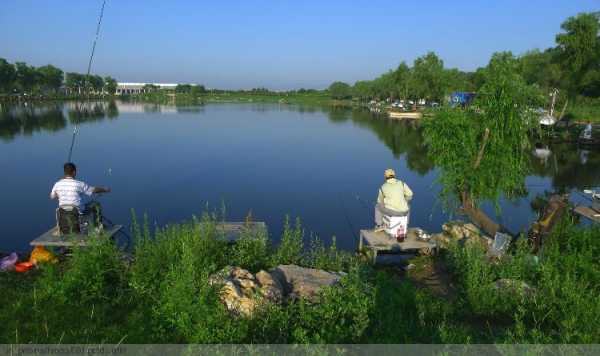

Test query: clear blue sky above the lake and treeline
[0,0,600,89]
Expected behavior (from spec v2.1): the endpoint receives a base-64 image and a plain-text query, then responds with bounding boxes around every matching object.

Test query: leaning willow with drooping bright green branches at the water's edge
[424,52,540,236]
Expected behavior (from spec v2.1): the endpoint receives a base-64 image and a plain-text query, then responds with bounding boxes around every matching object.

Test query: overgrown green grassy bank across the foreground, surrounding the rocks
[0,215,600,344]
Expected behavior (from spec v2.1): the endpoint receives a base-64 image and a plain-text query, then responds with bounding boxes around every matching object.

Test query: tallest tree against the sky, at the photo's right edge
[556,13,600,97]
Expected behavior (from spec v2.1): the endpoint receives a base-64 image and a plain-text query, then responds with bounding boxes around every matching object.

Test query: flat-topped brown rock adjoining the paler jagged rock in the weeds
[269,265,344,301]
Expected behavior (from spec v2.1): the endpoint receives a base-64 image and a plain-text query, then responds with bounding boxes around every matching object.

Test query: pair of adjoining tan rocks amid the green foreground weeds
[209,265,343,316]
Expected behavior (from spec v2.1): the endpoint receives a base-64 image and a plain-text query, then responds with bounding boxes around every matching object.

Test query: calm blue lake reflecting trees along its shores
[0,98,600,251]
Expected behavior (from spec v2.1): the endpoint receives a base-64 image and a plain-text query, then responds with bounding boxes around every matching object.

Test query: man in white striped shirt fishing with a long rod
[50,162,110,234]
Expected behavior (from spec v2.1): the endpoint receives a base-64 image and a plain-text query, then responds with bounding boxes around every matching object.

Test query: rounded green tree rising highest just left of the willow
[411,52,446,101]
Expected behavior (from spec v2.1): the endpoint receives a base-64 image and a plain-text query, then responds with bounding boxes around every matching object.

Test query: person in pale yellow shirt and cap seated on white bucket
[375,169,413,227]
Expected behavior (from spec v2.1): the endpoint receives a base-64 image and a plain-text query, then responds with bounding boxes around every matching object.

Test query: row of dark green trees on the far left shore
[0,58,117,98]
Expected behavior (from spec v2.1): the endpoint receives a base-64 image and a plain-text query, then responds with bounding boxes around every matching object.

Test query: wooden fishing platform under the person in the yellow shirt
[358,228,437,264]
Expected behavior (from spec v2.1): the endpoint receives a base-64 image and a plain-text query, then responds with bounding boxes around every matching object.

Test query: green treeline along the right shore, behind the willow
[329,12,600,112]
